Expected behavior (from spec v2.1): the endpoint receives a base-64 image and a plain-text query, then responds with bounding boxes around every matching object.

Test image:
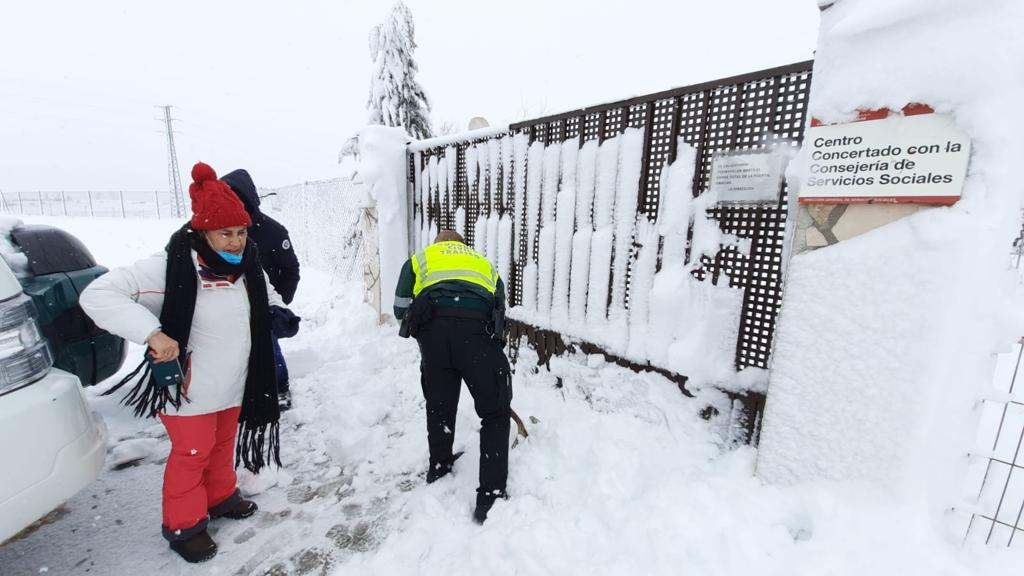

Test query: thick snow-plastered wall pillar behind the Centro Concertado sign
[757,0,1024,538]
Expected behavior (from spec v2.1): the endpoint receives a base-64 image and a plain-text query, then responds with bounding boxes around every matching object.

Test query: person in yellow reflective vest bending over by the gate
[394,231,512,524]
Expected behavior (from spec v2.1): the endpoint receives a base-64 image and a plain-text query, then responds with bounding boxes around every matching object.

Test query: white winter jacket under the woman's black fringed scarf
[79,250,285,416]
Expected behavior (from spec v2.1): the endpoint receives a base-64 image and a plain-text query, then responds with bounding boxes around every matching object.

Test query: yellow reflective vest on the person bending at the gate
[412,242,498,296]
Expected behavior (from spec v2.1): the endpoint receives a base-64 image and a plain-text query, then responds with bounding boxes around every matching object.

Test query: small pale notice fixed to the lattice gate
[711,151,783,202]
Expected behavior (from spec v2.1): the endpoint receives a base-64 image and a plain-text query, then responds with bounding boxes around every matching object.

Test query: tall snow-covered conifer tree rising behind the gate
[367,0,433,139]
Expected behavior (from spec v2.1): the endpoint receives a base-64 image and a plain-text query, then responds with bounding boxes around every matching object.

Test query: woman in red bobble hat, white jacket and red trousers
[81,163,284,562]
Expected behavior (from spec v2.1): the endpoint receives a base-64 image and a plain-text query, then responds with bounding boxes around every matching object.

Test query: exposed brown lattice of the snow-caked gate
[409,60,813,442]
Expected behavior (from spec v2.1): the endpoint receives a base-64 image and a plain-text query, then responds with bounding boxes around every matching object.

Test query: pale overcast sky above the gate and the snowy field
[0,0,818,192]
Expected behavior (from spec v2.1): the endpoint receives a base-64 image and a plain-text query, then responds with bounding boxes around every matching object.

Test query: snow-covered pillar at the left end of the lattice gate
[358,126,409,322]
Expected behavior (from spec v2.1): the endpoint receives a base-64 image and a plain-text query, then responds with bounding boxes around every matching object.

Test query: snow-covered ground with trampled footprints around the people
[0,213,1024,576]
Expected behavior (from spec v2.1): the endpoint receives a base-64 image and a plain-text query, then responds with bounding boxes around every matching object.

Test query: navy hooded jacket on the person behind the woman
[220,170,299,304]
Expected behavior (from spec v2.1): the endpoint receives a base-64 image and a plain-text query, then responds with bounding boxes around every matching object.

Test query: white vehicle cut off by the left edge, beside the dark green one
[0,223,106,544]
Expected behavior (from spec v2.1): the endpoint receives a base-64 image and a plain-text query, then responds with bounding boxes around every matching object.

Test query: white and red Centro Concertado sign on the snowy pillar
[800,105,971,204]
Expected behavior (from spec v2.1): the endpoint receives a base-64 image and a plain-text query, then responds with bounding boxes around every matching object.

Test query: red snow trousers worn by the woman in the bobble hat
[160,407,242,539]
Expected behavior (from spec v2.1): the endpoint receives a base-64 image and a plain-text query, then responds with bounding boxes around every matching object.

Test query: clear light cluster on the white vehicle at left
[0,294,53,395]
